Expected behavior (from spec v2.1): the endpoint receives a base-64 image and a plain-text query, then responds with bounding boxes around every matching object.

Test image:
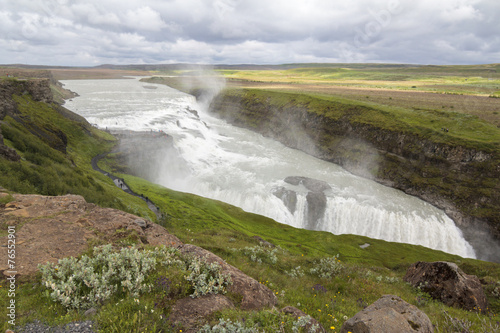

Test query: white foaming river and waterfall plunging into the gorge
[63,79,475,257]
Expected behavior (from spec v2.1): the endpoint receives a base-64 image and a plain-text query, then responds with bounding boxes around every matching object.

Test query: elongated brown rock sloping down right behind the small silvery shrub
[179,244,277,310]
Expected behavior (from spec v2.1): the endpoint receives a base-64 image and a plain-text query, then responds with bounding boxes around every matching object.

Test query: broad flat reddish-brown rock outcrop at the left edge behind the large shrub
[0,193,182,275]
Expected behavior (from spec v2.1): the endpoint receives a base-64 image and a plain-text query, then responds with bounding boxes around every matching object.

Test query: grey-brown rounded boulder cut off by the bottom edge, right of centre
[340,295,434,333]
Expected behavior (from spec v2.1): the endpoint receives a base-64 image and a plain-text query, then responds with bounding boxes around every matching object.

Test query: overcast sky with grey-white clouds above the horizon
[0,0,500,66]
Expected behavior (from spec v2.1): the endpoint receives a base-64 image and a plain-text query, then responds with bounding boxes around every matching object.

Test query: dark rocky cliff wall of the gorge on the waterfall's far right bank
[210,90,500,262]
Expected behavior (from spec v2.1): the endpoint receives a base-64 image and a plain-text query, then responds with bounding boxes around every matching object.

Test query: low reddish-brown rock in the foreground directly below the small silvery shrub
[170,295,234,332]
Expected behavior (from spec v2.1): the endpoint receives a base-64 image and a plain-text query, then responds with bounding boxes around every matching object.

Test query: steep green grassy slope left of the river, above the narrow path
[0,95,156,221]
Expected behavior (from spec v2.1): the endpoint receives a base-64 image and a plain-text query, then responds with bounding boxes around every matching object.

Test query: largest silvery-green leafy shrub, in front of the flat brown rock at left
[38,245,175,309]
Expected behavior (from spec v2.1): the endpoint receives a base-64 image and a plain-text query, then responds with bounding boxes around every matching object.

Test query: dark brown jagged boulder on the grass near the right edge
[404,261,488,312]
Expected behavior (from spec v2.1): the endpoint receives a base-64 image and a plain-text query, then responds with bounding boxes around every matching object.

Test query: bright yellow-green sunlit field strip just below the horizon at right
[219,64,500,96]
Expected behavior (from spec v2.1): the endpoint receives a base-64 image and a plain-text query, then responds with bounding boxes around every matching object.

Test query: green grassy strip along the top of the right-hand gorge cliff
[221,88,500,152]
